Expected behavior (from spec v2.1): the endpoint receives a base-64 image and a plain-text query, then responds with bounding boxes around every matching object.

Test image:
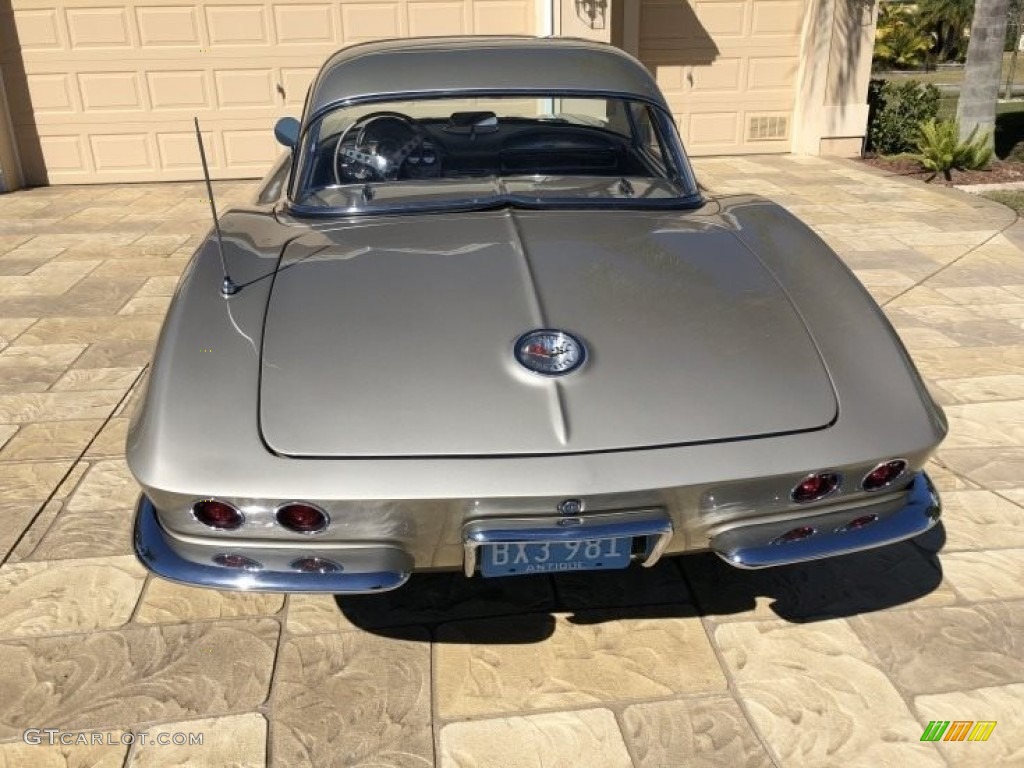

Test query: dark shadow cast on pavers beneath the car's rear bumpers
[335,523,945,644]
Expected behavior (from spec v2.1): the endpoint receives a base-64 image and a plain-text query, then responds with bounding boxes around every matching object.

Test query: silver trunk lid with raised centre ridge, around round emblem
[260,210,837,457]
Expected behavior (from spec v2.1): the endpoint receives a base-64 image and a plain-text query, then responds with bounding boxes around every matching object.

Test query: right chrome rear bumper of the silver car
[711,472,942,568]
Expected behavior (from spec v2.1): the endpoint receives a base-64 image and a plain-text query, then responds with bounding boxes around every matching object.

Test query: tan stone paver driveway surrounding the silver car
[0,158,1024,768]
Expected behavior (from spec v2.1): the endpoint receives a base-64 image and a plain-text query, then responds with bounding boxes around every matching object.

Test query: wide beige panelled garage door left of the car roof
[0,0,536,184]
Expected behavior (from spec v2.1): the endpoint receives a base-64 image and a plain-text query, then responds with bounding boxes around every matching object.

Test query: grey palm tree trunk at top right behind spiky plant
[956,0,1010,146]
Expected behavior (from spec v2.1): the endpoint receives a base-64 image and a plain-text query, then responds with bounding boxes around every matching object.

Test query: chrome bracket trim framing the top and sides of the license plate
[463,509,674,577]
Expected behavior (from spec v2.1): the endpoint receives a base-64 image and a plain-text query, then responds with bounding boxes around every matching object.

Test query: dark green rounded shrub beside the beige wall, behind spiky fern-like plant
[867,80,941,155]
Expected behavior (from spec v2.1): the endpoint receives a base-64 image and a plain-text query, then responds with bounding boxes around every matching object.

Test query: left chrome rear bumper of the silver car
[133,496,413,595]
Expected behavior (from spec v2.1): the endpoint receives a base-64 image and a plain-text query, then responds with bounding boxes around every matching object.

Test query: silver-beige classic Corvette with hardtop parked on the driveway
[127,38,946,593]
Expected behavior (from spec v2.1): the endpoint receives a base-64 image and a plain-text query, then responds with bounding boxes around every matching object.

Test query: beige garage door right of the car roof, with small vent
[640,0,807,155]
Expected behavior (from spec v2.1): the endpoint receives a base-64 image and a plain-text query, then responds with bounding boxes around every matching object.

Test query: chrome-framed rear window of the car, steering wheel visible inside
[291,94,699,213]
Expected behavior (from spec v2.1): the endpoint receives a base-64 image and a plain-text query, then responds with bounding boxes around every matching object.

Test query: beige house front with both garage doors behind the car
[0,0,876,186]
